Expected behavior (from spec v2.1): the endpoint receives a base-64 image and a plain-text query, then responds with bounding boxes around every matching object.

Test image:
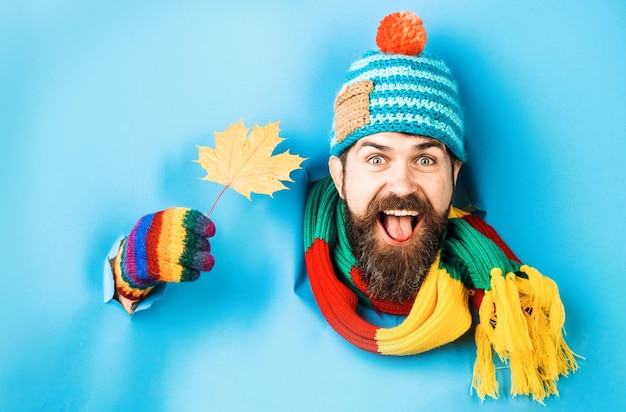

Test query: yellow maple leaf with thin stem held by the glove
[195,120,306,214]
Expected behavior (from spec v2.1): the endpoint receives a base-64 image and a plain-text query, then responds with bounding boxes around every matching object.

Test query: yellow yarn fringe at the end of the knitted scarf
[472,265,578,404]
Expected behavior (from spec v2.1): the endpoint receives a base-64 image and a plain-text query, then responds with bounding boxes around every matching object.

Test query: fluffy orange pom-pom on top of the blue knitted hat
[376,11,426,56]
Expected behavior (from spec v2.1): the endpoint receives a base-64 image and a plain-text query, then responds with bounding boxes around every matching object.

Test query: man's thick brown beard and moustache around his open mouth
[346,194,448,303]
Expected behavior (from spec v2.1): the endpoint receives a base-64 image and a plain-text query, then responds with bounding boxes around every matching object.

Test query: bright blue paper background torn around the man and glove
[0,0,626,411]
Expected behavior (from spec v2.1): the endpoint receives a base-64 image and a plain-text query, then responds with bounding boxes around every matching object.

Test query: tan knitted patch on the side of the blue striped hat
[335,80,374,143]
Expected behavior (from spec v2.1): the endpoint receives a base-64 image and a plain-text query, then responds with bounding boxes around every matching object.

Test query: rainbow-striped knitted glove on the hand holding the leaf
[113,208,215,301]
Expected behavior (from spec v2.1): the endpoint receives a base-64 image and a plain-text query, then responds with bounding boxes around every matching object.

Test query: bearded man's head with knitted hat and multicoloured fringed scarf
[305,12,578,402]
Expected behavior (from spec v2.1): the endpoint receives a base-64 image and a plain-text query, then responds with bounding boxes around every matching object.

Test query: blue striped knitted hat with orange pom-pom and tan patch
[330,12,467,161]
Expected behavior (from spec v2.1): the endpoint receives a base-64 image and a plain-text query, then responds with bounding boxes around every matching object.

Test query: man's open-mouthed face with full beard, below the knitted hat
[329,132,461,302]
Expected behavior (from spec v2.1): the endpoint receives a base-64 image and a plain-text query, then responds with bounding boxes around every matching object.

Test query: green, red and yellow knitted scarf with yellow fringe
[304,177,578,403]
